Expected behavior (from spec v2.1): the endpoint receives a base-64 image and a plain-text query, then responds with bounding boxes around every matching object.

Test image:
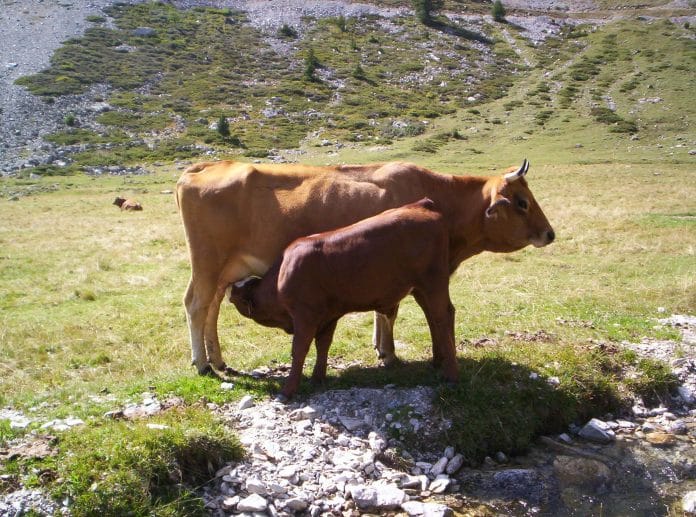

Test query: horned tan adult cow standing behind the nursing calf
[177,160,554,374]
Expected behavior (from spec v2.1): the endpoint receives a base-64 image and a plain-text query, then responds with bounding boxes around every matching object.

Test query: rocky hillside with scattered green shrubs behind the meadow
[0,0,696,175]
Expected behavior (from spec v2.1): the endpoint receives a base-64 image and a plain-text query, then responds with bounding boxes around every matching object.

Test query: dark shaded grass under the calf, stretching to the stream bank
[227,356,621,462]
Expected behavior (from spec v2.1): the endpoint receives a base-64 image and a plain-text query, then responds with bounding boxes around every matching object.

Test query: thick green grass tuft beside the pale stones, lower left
[49,408,242,516]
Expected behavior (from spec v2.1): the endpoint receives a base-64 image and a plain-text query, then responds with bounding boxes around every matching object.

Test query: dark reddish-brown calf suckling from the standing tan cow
[229,198,458,397]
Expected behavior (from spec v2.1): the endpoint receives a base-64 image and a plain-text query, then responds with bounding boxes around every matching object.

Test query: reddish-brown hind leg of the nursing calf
[413,284,459,382]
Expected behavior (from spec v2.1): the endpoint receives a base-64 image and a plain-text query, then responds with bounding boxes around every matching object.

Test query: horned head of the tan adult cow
[484,159,556,252]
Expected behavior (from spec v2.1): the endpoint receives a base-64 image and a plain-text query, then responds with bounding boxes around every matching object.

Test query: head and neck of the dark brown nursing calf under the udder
[228,276,293,333]
